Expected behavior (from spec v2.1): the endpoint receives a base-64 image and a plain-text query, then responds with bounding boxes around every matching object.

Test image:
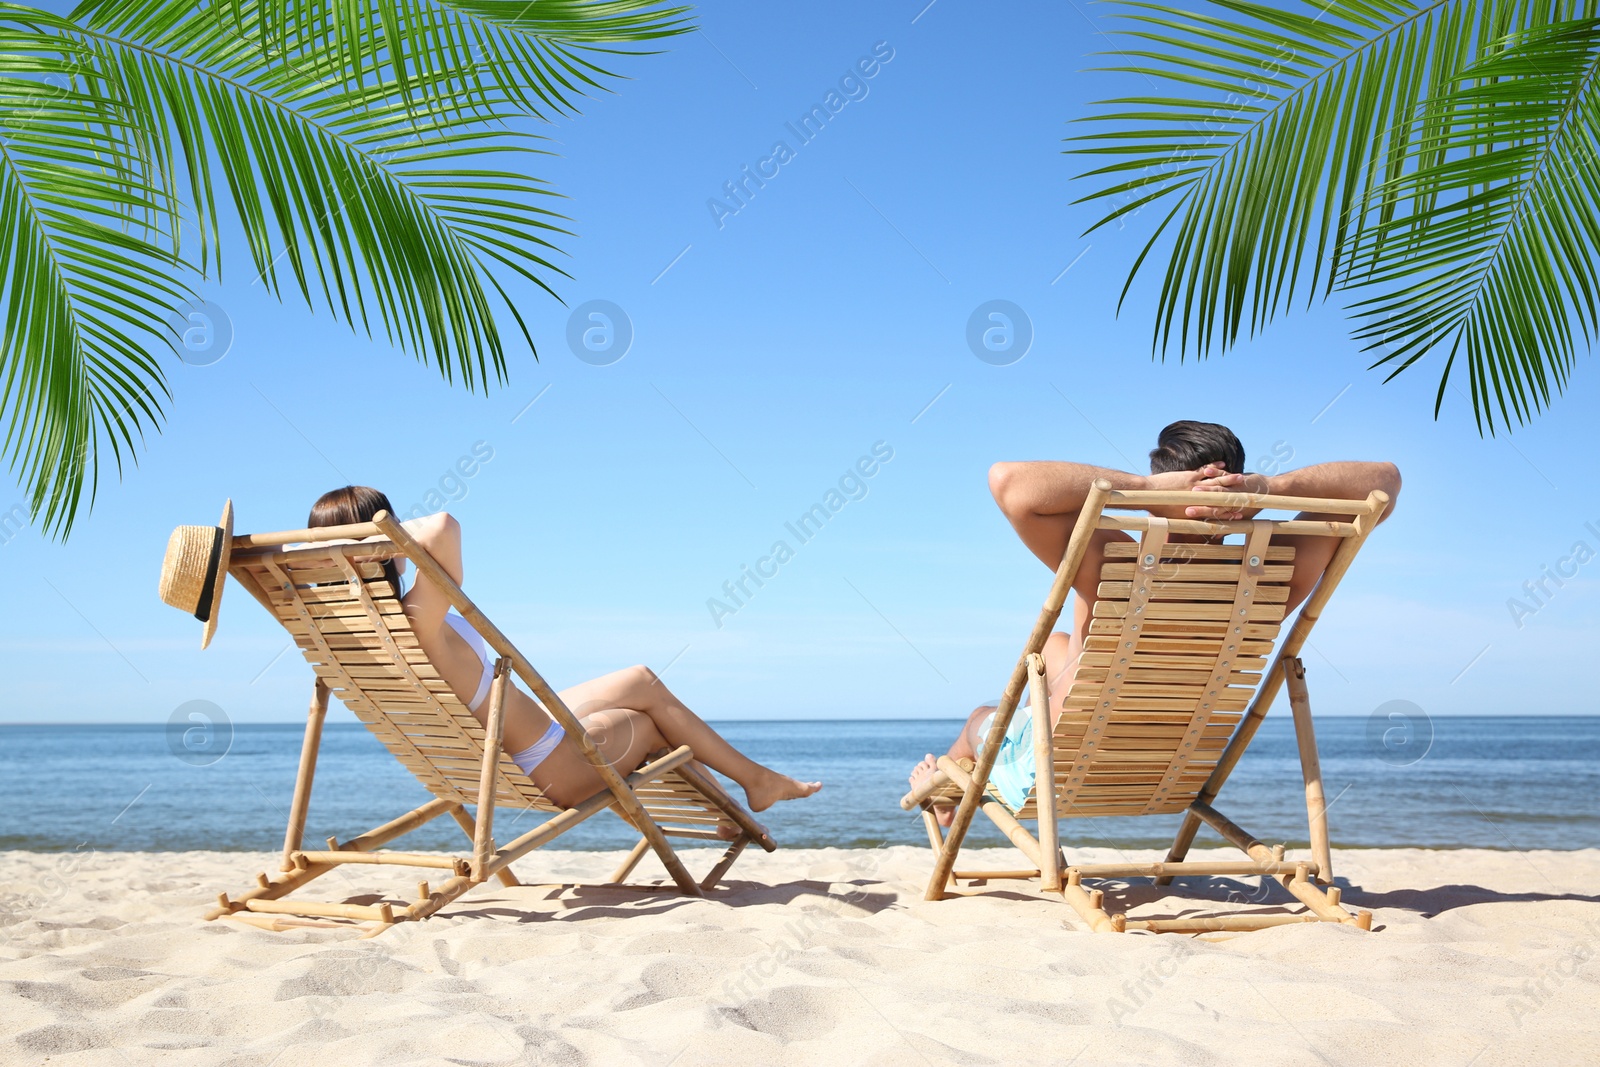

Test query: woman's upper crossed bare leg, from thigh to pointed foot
[562,667,822,811]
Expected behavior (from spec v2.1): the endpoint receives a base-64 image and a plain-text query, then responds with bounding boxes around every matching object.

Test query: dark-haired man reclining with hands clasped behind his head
[910,422,1400,825]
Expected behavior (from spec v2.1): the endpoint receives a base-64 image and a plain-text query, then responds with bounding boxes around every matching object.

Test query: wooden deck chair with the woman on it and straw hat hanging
[206,512,776,936]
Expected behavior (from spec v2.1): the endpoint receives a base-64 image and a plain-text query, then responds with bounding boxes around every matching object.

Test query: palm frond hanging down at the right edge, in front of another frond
[1349,19,1600,432]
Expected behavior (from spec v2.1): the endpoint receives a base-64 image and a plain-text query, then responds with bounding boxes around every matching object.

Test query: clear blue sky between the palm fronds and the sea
[0,0,1600,721]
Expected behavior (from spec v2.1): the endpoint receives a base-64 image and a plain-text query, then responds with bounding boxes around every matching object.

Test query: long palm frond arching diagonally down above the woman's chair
[82,14,562,389]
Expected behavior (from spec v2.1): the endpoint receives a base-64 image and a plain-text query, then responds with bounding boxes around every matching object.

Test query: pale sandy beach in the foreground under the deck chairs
[0,848,1600,1067]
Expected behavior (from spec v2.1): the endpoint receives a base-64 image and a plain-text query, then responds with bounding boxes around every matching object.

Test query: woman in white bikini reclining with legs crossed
[307,485,822,811]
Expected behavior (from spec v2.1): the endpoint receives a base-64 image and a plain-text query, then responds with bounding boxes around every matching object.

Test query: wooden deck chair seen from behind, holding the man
[901,480,1389,933]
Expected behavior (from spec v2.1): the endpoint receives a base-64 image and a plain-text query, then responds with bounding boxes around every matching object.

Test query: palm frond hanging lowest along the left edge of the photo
[0,13,189,528]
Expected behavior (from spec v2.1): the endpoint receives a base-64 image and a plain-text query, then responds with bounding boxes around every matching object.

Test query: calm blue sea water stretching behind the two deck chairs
[0,717,1600,851]
